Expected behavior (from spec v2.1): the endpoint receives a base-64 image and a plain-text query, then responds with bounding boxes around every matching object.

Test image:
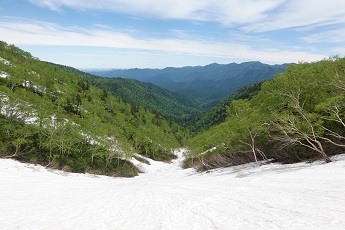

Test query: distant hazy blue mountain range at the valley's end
[89,62,290,104]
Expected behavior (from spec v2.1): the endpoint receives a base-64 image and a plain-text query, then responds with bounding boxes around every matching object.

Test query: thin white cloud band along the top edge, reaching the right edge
[29,0,345,32]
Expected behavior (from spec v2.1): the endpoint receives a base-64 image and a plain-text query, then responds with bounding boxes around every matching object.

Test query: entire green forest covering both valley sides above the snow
[0,42,345,176]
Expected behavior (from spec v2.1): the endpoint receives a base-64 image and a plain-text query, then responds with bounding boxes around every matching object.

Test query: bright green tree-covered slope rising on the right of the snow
[186,58,345,169]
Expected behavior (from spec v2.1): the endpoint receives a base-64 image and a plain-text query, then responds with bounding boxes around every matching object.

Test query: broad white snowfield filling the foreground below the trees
[0,152,345,230]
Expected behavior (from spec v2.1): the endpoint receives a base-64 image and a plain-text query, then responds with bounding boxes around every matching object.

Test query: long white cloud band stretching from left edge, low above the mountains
[0,18,324,63]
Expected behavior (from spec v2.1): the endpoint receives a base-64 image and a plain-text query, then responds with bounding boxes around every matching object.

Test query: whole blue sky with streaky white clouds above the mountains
[0,0,345,69]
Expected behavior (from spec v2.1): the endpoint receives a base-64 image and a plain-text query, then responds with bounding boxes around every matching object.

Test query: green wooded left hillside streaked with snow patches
[0,42,184,176]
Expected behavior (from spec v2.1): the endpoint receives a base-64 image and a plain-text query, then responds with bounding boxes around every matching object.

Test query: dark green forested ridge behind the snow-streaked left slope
[50,63,202,122]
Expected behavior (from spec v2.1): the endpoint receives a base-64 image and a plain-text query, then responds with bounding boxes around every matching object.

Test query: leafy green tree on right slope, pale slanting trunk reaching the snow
[255,63,330,162]
